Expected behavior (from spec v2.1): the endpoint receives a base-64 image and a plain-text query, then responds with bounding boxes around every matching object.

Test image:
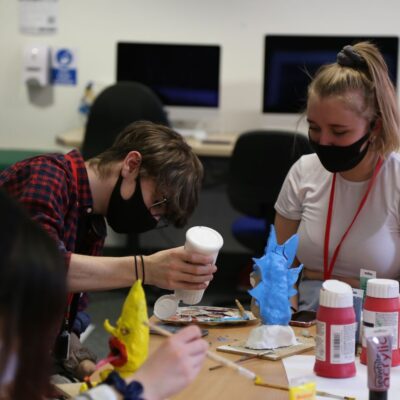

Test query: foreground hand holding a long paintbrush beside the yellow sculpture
[128,325,208,400]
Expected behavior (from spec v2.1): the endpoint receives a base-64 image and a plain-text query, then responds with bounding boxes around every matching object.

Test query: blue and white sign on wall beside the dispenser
[51,48,78,85]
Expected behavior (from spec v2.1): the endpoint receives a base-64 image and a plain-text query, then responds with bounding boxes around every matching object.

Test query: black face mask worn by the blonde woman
[308,132,370,172]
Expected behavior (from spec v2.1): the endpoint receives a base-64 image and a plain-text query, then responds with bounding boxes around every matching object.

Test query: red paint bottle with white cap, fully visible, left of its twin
[314,279,356,378]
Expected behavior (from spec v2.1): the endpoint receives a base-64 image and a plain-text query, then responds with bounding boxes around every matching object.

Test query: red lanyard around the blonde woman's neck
[324,158,383,280]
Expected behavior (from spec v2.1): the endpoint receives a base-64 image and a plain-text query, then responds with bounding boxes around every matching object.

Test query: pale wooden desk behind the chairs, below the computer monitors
[56,128,238,157]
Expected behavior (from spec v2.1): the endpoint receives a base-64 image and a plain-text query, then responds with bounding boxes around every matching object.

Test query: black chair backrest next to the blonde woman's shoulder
[228,130,312,223]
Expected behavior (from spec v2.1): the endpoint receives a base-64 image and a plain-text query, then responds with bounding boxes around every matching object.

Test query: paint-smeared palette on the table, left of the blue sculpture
[158,306,258,325]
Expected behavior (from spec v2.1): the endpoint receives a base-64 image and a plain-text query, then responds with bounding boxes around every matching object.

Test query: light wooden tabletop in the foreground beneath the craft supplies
[57,317,313,400]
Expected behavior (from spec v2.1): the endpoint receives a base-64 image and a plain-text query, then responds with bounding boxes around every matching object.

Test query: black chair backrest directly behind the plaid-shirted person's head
[82,82,169,159]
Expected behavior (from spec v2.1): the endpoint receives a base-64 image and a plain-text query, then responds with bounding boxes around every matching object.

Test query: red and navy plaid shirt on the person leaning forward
[0,150,104,316]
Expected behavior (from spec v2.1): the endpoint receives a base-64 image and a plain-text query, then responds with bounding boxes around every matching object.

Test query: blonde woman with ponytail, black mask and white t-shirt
[275,42,400,309]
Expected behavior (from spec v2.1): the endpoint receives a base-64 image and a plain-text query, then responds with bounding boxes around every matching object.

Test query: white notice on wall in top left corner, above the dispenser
[19,0,58,35]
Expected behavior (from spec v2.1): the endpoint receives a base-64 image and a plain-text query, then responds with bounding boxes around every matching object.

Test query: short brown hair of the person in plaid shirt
[89,121,203,227]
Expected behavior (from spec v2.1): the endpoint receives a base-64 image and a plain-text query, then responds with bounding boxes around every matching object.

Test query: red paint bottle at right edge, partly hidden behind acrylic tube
[360,279,400,367]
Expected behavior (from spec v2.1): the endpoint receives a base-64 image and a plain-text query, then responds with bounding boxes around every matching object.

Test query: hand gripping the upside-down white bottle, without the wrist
[144,246,217,290]
